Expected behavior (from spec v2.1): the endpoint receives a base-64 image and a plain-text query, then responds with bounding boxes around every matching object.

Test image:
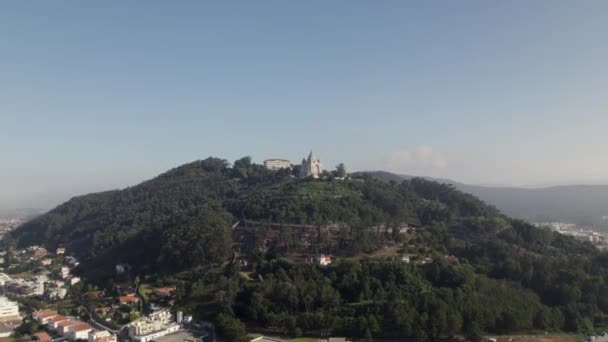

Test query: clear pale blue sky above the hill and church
[0,0,608,208]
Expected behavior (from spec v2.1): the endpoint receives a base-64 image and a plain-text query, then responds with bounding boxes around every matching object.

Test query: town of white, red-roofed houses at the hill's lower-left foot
[0,246,214,342]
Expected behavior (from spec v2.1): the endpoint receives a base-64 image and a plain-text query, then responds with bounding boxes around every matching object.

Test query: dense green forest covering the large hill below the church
[12,158,608,341]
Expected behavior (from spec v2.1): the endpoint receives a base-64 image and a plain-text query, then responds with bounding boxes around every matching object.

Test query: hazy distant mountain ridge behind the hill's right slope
[358,171,608,230]
